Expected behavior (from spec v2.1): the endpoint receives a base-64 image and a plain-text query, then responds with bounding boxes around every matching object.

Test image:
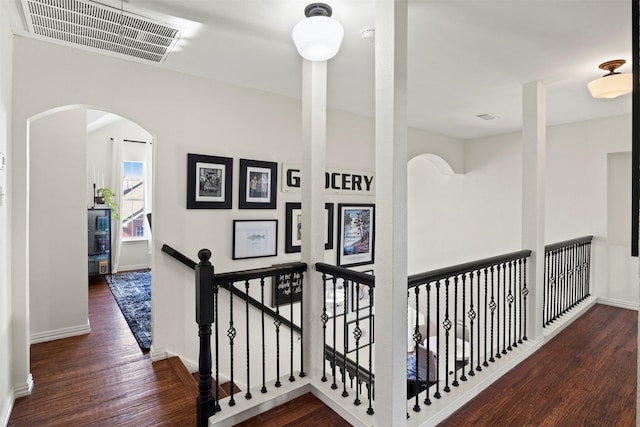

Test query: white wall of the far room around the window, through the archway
[87,114,153,271]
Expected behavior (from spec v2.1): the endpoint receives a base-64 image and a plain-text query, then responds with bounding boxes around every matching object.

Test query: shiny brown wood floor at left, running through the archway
[8,280,198,427]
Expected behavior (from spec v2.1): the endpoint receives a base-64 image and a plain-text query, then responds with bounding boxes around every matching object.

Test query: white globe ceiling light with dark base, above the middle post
[291,3,344,61]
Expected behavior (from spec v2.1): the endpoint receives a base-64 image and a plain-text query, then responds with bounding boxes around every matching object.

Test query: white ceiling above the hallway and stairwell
[6,0,631,139]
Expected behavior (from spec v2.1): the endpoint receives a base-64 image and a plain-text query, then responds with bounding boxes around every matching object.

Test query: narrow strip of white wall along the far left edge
[0,2,13,425]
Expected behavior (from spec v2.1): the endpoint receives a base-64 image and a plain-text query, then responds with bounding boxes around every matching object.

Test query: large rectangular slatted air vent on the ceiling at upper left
[22,0,180,62]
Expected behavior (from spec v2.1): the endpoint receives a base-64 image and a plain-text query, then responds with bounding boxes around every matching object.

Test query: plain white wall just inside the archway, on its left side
[29,109,89,342]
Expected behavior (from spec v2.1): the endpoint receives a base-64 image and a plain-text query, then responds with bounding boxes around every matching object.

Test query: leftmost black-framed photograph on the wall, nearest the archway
[187,154,233,209]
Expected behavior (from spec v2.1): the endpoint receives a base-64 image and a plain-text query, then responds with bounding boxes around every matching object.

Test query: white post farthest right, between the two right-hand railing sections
[522,82,546,339]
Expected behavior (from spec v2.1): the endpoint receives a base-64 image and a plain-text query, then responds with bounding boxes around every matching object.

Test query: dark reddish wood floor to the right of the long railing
[440,304,638,427]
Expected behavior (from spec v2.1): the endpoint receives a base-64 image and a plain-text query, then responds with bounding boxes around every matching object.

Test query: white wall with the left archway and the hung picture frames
[12,37,450,374]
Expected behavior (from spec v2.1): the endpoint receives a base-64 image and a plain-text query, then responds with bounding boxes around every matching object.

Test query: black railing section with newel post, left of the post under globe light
[162,245,307,426]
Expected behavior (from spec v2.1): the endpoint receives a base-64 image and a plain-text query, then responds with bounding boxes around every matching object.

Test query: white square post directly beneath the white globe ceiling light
[300,60,327,374]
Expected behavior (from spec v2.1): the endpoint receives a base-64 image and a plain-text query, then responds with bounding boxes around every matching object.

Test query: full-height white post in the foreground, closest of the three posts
[374,0,407,427]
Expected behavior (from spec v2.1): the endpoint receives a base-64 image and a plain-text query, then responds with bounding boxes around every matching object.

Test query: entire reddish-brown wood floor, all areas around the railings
[8,281,637,427]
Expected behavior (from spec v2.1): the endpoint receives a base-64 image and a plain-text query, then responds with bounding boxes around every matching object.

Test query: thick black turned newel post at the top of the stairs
[196,249,215,426]
